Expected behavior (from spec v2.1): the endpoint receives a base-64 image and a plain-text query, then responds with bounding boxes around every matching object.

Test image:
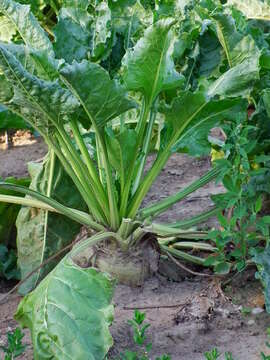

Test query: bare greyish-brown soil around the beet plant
[0,134,270,360]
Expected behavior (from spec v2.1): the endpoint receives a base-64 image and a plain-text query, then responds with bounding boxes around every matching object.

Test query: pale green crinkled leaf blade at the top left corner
[0,0,54,56]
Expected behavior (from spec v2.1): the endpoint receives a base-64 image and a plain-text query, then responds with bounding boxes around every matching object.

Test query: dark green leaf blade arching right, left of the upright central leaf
[60,60,135,129]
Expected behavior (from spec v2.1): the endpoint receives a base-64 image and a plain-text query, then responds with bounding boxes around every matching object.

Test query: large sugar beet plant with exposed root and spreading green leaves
[0,0,261,359]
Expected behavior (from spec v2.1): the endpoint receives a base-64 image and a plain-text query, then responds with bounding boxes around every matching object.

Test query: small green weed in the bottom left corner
[0,328,26,360]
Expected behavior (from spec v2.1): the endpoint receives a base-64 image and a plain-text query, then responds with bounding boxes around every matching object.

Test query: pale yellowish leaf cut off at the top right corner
[227,0,270,20]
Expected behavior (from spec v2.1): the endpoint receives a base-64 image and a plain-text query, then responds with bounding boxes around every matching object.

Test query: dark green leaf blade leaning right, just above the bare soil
[160,87,250,155]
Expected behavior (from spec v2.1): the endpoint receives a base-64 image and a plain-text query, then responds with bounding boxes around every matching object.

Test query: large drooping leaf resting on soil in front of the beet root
[15,256,113,360]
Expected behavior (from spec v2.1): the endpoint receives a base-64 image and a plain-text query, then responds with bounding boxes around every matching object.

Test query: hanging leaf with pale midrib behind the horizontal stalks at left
[16,154,85,294]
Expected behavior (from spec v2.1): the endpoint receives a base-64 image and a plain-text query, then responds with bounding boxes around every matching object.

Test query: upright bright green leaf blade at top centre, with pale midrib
[123,19,183,104]
